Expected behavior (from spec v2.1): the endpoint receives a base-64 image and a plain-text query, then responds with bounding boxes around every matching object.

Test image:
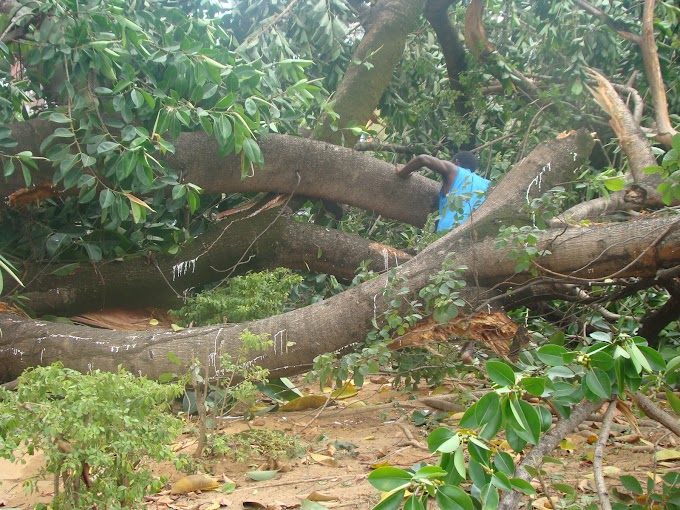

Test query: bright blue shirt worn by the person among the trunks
[437,167,491,232]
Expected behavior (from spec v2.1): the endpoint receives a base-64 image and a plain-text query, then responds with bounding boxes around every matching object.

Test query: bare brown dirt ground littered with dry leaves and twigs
[0,379,680,510]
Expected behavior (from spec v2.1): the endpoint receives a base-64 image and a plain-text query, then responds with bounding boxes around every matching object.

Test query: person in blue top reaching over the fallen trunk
[397,151,490,232]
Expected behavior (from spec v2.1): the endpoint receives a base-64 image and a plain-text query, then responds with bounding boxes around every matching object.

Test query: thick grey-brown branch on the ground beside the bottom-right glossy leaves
[498,400,602,510]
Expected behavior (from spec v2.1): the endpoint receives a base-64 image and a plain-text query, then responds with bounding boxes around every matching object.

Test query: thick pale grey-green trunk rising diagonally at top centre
[313,0,425,147]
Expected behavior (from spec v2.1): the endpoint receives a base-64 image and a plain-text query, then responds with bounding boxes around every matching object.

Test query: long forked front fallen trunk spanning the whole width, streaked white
[5,131,680,381]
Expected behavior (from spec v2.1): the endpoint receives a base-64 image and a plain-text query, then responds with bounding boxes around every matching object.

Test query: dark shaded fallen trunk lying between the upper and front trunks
[14,207,411,316]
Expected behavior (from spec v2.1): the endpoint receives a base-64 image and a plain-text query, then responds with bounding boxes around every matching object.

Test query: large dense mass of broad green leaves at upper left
[0,0,323,261]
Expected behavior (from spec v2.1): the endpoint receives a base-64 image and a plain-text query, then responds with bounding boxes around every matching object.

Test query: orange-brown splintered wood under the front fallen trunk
[389,312,529,359]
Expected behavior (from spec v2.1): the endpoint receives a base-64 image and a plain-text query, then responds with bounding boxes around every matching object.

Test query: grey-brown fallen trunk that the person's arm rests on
[0,120,439,226]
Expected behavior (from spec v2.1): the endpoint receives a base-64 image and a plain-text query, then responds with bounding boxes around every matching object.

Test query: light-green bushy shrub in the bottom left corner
[0,363,183,509]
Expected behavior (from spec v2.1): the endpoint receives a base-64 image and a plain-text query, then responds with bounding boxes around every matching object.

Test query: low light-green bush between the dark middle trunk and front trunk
[172,268,302,326]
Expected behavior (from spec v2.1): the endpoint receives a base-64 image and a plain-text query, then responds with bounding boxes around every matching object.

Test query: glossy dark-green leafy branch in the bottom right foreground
[369,334,680,509]
